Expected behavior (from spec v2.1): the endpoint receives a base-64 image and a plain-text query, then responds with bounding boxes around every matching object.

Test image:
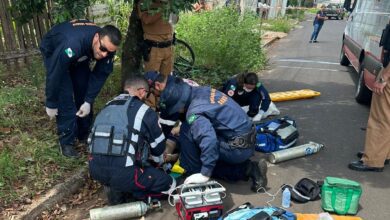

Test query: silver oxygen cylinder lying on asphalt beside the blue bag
[268,141,324,163]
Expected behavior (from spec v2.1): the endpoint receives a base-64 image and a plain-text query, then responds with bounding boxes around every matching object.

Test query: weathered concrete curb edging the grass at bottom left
[15,167,88,220]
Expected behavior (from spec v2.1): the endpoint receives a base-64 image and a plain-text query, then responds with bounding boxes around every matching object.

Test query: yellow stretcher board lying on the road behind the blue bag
[269,89,321,102]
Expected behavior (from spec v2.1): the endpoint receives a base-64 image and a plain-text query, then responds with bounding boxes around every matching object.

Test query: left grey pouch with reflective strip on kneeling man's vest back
[89,125,114,155]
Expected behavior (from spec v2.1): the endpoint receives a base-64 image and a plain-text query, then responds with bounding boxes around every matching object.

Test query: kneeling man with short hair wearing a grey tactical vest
[88,77,176,205]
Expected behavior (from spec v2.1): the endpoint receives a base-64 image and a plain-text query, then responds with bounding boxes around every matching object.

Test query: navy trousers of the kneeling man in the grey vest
[89,155,173,200]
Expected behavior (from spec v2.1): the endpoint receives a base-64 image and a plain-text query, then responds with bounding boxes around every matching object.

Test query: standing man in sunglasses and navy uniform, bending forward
[40,20,121,157]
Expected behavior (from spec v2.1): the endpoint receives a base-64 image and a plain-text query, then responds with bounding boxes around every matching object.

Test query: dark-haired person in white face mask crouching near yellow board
[221,73,271,119]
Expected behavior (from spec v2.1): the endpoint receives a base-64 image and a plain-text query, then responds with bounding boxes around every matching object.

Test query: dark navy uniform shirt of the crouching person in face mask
[222,78,271,117]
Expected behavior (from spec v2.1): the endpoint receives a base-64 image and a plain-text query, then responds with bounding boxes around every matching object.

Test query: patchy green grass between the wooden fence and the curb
[0,58,121,208]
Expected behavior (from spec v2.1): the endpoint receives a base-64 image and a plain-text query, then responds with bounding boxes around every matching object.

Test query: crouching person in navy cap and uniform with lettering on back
[159,82,267,191]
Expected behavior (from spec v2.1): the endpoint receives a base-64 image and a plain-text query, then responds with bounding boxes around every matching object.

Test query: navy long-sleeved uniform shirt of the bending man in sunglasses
[40,21,115,108]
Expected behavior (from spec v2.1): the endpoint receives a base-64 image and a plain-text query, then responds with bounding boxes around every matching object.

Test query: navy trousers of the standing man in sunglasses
[57,61,93,145]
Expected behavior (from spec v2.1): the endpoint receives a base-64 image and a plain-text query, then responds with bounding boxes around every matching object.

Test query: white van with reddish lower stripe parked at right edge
[340,0,390,104]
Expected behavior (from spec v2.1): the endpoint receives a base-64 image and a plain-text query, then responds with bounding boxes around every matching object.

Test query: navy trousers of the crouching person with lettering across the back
[179,122,254,181]
